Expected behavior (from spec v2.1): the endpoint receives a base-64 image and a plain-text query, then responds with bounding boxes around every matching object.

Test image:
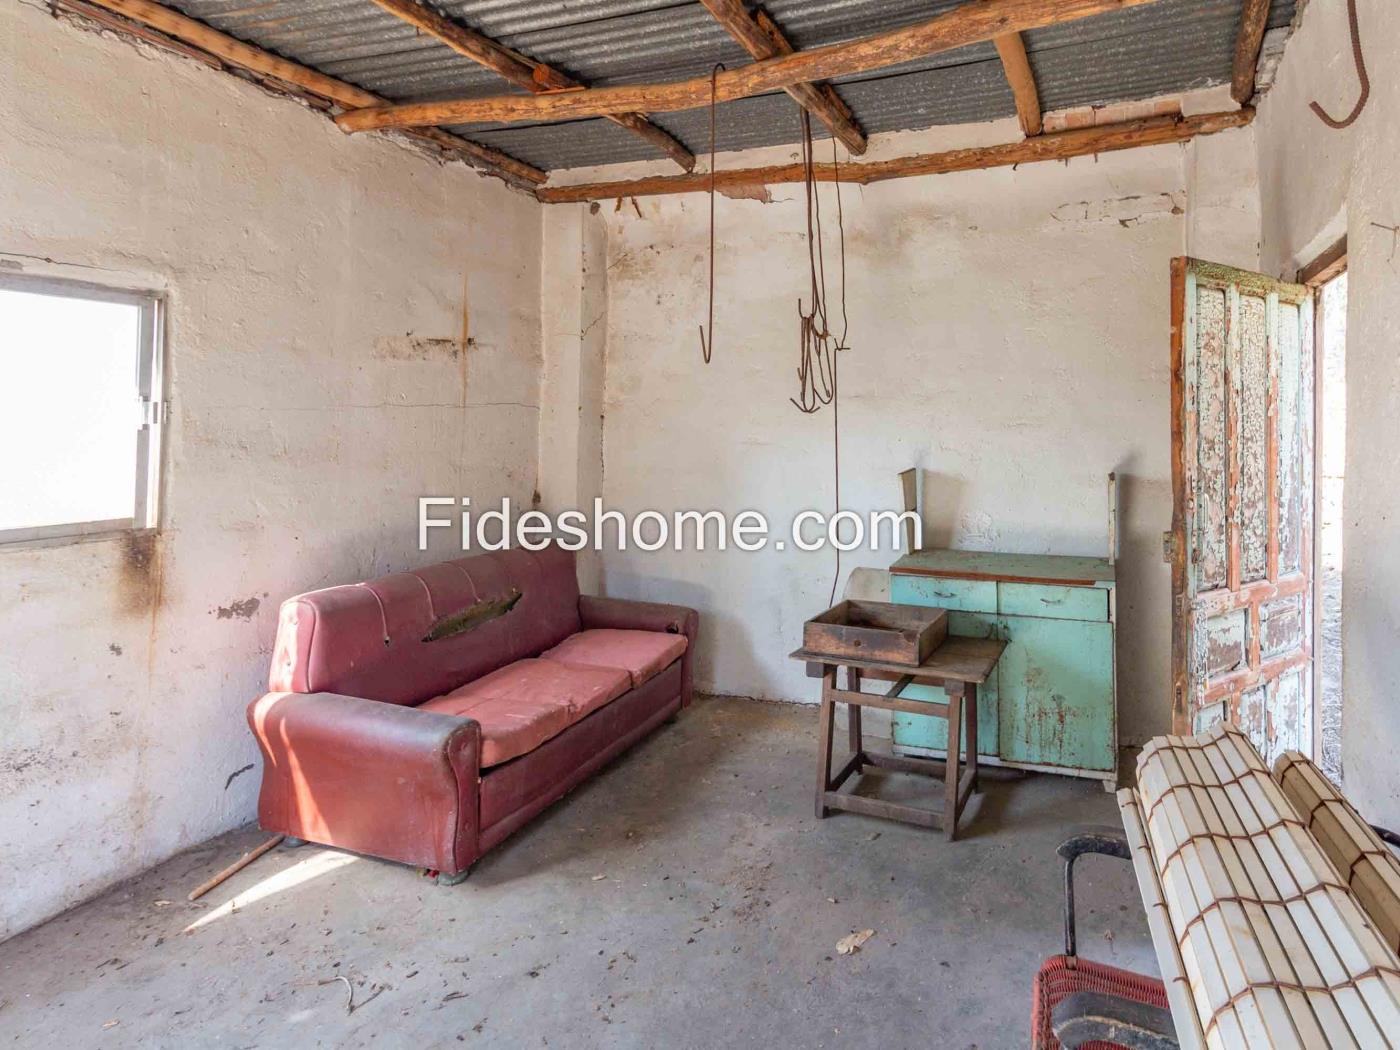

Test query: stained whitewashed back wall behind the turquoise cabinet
[562,122,1259,741]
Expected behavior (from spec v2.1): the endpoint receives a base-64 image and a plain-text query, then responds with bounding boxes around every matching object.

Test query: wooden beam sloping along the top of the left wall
[74,0,547,188]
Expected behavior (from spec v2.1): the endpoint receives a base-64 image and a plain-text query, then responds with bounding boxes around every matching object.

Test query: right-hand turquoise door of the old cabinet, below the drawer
[997,616,1116,770]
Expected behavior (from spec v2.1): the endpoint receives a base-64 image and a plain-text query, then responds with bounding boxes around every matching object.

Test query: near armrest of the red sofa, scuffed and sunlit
[248,693,482,874]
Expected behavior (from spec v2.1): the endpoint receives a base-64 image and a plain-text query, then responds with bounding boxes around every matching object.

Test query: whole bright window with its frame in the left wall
[0,276,164,543]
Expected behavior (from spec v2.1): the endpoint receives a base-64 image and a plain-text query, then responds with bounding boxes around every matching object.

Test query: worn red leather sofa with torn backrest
[248,547,697,881]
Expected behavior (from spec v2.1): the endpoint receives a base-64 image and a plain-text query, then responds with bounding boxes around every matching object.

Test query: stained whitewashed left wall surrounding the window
[0,3,540,938]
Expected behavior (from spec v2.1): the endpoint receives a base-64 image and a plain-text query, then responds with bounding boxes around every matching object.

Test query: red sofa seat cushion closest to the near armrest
[419,659,631,769]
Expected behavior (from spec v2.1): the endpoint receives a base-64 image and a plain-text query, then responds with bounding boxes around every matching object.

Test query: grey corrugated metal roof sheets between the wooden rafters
[161,0,1295,168]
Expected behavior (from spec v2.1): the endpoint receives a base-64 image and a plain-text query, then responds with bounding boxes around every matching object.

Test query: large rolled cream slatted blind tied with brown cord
[1119,724,1400,1050]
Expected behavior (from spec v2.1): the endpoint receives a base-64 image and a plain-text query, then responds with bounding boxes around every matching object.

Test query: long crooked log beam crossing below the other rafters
[336,0,1154,132]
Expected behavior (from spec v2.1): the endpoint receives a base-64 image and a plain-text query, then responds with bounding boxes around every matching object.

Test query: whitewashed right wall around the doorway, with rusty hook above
[1256,0,1400,827]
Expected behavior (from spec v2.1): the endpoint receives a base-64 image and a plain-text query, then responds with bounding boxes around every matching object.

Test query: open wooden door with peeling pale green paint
[1170,259,1313,762]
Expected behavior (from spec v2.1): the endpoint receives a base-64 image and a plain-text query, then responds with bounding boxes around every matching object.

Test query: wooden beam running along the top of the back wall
[535,106,1254,204]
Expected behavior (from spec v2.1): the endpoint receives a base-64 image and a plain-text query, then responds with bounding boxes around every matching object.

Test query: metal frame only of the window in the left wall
[0,273,167,549]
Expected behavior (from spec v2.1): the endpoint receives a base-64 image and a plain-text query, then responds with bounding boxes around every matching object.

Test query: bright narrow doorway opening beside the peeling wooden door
[1315,270,1347,784]
